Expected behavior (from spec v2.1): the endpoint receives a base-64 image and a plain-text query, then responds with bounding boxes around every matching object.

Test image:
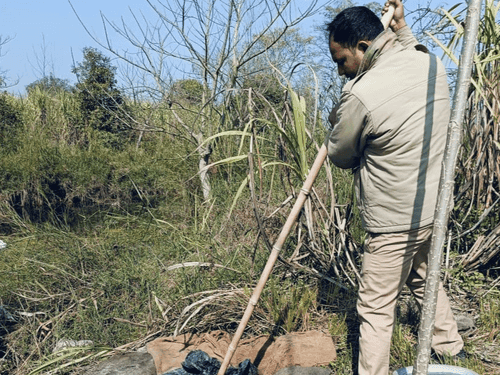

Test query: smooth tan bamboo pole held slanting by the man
[217,6,394,375]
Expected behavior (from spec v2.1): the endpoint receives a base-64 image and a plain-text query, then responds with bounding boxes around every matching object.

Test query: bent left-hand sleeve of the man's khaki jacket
[325,92,368,169]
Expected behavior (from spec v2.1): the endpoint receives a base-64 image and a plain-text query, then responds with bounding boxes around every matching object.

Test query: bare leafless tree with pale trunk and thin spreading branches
[73,0,326,199]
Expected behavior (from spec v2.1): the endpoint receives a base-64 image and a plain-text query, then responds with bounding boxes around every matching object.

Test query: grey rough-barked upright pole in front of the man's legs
[413,0,481,375]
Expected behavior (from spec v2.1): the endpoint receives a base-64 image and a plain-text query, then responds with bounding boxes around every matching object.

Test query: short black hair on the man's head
[327,6,384,48]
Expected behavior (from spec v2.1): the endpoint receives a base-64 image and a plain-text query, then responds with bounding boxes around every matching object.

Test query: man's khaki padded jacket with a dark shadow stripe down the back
[325,27,450,233]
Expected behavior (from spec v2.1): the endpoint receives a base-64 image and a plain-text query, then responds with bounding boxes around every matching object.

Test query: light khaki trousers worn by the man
[357,225,463,375]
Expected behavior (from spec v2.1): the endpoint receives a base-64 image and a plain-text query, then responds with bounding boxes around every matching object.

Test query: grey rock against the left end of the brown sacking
[84,352,156,375]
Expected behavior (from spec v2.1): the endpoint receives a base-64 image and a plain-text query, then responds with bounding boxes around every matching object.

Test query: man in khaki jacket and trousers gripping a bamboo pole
[325,0,464,375]
